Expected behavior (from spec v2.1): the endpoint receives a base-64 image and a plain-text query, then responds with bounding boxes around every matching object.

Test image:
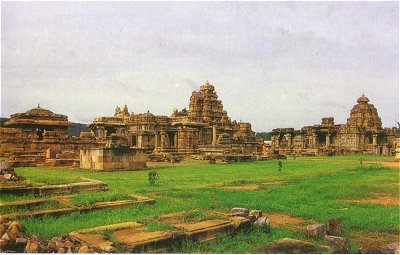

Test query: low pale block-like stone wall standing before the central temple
[79,148,148,171]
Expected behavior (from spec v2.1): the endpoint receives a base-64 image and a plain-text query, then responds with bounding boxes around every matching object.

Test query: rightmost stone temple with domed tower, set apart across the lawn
[270,95,399,155]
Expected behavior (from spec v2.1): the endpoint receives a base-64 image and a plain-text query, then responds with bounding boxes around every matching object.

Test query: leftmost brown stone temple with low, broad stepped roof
[0,105,98,166]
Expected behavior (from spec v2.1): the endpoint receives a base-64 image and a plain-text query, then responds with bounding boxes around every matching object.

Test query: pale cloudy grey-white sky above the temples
[1,2,399,132]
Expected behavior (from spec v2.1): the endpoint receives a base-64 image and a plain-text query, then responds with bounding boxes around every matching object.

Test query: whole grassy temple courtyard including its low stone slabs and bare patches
[0,154,400,253]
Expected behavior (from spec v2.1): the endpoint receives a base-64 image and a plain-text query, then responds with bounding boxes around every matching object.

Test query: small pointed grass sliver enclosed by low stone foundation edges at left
[71,191,135,206]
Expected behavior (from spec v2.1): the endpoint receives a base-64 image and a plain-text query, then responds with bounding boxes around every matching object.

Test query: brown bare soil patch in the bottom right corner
[350,233,400,253]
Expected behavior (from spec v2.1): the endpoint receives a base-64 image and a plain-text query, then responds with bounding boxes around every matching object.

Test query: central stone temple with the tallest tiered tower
[90,82,263,155]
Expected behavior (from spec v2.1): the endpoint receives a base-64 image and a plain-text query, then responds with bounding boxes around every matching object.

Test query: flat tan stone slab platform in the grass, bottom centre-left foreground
[70,211,251,253]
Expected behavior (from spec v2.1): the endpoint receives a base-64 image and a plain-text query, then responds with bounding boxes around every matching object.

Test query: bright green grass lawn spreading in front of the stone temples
[6,155,400,253]
